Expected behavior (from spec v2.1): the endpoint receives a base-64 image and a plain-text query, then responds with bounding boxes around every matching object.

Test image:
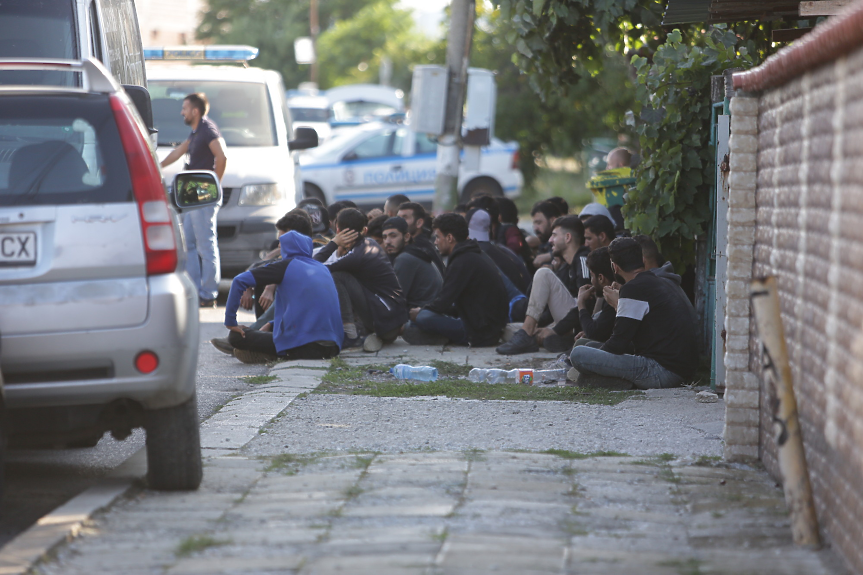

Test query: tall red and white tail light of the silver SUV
[111,94,177,276]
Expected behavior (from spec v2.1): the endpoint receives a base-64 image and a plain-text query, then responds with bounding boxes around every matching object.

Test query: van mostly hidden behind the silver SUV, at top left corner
[0,0,147,87]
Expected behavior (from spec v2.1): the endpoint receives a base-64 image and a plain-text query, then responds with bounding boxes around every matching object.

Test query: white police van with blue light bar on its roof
[144,46,317,274]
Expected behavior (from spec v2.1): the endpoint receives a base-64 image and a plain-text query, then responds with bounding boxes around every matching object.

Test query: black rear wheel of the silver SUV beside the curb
[144,395,203,491]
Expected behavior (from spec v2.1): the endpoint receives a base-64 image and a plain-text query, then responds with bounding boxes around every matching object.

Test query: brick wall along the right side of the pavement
[726,49,863,574]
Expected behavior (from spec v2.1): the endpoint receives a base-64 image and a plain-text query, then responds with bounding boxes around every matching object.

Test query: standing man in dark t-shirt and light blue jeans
[161,93,228,307]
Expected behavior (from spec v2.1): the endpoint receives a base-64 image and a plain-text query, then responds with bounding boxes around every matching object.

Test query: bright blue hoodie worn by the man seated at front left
[225,231,345,354]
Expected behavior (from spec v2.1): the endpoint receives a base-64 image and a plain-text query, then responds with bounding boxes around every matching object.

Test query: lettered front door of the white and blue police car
[335,126,407,204]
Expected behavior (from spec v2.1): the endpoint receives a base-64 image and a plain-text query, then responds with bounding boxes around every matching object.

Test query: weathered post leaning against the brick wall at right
[750,277,821,547]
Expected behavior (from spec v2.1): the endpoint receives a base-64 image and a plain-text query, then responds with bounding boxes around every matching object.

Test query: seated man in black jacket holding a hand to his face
[315,208,408,351]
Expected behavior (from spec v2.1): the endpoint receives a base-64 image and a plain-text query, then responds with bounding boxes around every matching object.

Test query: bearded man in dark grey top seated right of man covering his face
[383,216,443,309]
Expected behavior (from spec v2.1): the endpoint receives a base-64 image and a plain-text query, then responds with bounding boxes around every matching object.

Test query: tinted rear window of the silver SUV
[0,95,132,206]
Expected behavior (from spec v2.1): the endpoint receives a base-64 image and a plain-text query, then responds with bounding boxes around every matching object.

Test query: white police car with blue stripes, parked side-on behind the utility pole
[300,122,523,205]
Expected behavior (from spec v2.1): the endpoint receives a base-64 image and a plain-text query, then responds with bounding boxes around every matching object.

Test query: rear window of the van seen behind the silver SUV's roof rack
[0,0,79,86]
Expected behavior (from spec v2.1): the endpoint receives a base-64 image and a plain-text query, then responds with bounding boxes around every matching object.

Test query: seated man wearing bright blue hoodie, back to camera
[225,212,345,363]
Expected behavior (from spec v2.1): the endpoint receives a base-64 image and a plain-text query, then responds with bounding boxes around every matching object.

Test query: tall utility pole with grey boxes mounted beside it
[432,0,476,213]
